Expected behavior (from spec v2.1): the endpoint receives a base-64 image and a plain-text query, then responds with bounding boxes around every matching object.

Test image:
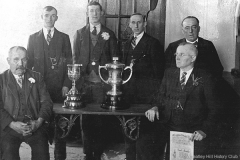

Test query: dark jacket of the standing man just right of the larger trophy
[122,33,165,103]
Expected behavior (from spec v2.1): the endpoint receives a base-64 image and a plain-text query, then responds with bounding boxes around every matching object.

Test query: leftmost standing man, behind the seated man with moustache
[27,6,72,102]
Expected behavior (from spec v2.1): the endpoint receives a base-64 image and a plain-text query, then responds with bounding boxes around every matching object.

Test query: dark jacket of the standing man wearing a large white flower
[73,24,118,73]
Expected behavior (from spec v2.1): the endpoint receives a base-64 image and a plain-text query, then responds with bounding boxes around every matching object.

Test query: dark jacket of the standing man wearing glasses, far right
[165,37,223,77]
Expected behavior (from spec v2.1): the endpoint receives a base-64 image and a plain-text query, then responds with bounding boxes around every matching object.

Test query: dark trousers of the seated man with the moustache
[1,126,50,160]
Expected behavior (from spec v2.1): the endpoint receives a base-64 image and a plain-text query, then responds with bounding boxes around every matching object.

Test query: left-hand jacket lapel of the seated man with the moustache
[7,70,19,103]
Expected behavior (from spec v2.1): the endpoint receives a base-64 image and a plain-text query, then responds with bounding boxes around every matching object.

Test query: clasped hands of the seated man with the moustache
[9,121,32,136]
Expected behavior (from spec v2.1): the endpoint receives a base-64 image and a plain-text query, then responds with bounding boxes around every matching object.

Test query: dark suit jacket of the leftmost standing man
[27,28,72,88]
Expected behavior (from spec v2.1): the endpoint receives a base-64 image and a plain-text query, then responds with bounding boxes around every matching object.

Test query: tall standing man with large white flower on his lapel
[73,1,118,160]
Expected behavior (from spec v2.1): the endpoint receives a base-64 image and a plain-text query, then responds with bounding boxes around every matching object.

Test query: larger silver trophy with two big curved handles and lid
[99,57,132,110]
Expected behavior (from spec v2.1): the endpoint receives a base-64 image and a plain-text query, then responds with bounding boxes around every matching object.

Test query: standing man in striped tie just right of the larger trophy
[122,13,165,160]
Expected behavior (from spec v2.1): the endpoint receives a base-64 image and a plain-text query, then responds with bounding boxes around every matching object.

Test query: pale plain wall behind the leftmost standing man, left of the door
[0,0,87,73]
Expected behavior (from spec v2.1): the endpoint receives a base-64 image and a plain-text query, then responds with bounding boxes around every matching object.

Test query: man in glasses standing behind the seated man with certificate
[165,16,223,77]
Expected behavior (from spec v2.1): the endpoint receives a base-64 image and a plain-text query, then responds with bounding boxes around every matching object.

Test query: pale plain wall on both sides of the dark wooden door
[0,0,240,73]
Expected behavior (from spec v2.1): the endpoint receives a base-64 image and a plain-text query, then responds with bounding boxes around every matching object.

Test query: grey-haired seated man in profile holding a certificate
[137,42,221,160]
